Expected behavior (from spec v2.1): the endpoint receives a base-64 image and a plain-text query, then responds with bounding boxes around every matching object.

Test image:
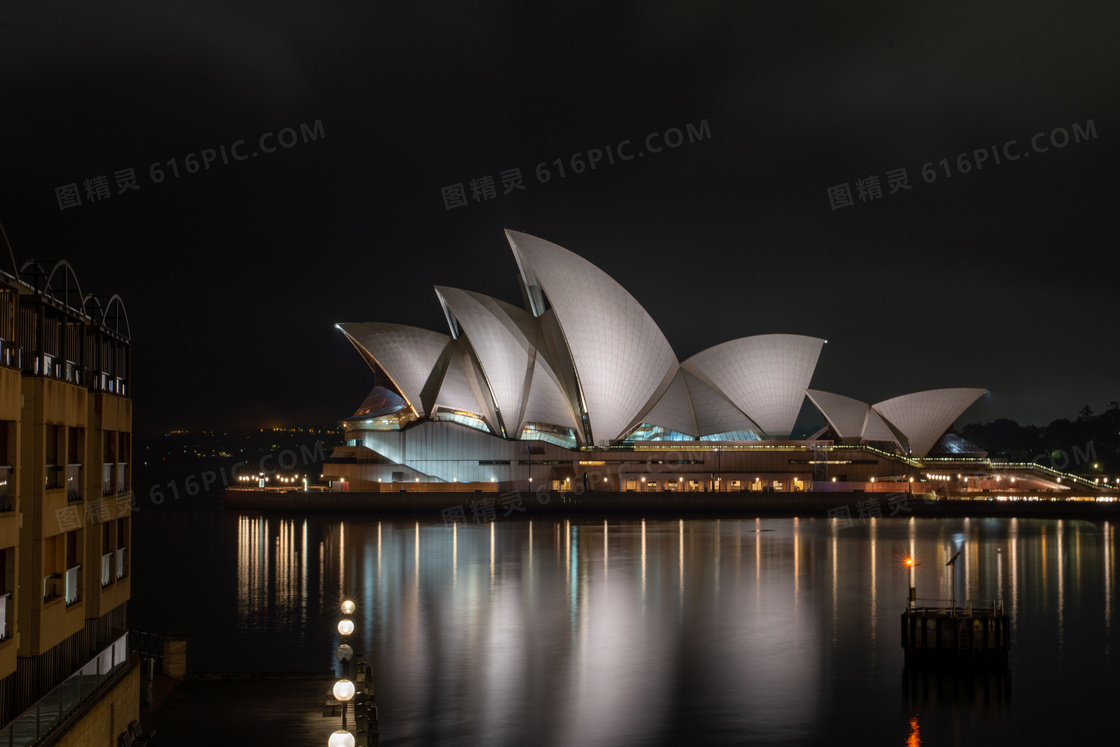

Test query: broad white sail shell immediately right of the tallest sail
[681,335,824,438]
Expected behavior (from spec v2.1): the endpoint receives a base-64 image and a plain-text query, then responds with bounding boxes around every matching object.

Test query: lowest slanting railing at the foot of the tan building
[0,633,129,747]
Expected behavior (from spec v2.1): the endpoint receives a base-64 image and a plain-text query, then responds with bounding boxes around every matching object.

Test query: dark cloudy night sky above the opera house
[0,1,1120,433]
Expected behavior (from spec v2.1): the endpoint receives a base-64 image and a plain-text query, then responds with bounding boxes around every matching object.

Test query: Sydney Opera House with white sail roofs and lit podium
[324,231,1093,493]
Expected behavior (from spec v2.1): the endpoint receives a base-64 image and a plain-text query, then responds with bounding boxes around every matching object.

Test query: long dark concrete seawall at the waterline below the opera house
[225,488,1120,521]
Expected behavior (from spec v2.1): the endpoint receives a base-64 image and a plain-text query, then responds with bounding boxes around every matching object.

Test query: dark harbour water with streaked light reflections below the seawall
[131,512,1116,745]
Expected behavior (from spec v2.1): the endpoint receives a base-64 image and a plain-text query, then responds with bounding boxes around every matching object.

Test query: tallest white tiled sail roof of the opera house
[506,231,678,445]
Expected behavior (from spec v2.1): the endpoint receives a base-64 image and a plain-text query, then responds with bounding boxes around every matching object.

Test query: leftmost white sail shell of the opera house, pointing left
[337,321,451,417]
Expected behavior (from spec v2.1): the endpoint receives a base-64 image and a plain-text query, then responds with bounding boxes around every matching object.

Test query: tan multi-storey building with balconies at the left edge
[0,236,139,745]
